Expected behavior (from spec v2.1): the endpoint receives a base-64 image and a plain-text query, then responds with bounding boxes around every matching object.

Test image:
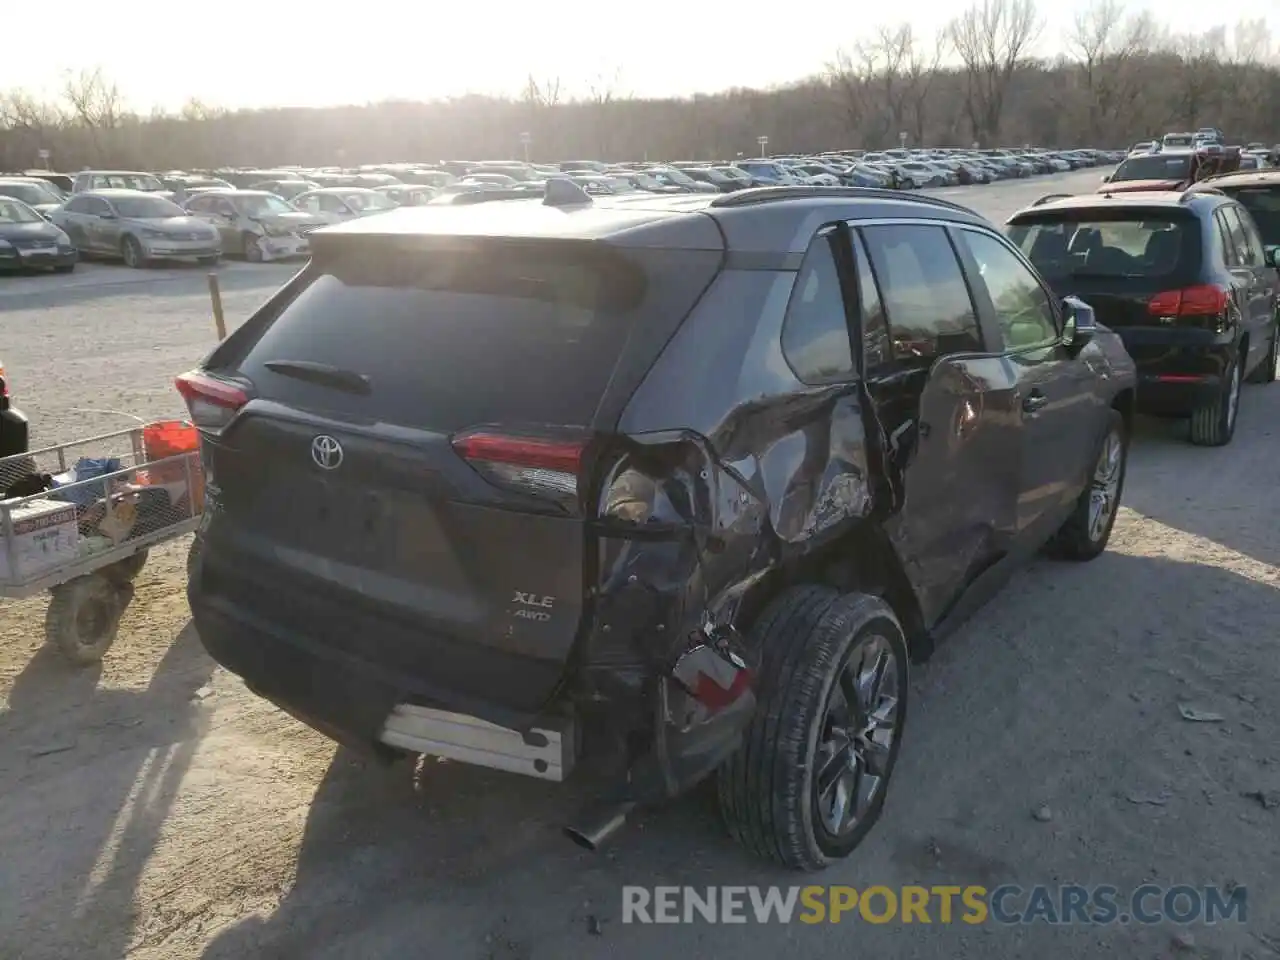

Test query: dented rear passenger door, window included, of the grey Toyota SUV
[855,223,1021,626]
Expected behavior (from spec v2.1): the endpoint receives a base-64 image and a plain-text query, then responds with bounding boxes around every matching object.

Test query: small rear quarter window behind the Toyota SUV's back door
[782,230,854,384]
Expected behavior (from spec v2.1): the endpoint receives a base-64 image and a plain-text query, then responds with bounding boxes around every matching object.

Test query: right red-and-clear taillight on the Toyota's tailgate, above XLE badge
[453,431,586,506]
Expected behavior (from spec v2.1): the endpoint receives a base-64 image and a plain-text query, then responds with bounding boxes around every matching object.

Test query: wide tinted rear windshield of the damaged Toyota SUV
[239,243,719,431]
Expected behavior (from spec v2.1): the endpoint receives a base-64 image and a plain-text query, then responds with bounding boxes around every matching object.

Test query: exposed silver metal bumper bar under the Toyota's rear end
[380,704,576,781]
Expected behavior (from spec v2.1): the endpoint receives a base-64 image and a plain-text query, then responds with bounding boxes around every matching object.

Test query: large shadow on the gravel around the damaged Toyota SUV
[204,553,1280,960]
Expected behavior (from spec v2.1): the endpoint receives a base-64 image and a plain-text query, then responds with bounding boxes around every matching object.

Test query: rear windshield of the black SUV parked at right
[1007,210,1198,282]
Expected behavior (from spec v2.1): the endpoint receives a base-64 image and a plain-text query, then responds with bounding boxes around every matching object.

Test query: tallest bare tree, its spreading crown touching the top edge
[947,0,1042,142]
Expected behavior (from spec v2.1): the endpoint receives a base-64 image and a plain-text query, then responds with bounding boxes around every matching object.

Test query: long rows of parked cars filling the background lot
[0,148,1120,270]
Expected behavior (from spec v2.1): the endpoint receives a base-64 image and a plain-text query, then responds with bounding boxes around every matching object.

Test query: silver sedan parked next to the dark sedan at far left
[50,189,221,268]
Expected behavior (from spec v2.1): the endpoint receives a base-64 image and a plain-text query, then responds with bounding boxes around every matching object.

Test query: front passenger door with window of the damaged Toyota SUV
[955,229,1102,549]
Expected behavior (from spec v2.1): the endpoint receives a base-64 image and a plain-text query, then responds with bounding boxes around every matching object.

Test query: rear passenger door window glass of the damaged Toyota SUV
[861,224,982,366]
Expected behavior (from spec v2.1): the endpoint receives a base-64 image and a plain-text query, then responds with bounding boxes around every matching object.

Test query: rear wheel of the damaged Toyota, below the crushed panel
[718,586,908,870]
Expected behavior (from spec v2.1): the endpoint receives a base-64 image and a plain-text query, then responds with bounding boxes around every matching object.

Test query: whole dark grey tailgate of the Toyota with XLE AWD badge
[200,238,718,709]
